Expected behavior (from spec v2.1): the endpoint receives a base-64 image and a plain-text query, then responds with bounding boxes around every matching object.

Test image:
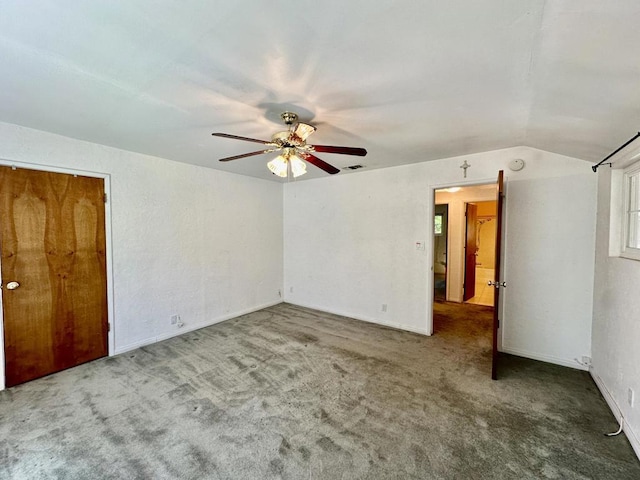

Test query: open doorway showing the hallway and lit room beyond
[433,182,498,376]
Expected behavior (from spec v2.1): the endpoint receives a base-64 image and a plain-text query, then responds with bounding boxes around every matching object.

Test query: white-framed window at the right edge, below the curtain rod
[622,162,640,260]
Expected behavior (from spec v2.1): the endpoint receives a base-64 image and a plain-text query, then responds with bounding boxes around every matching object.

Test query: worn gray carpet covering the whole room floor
[0,304,640,479]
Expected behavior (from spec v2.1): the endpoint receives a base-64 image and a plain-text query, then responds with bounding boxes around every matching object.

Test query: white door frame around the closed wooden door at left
[0,158,115,390]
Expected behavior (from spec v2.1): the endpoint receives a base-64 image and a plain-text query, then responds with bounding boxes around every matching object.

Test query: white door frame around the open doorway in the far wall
[425,176,508,338]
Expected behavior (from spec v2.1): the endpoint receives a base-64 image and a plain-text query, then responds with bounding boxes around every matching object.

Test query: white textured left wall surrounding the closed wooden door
[0,123,283,388]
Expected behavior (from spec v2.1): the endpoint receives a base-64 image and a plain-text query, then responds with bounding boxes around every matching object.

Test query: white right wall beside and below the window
[591,166,640,457]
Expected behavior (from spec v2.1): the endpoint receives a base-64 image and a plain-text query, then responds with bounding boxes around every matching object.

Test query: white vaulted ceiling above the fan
[0,0,640,180]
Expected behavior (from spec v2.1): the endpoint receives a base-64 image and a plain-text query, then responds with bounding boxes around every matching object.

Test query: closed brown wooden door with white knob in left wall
[0,167,108,386]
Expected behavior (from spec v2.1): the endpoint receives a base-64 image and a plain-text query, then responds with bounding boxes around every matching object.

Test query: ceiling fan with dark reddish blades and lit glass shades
[211,112,367,178]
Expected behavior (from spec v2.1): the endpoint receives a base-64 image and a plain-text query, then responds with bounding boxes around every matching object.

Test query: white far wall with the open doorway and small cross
[284,147,596,368]
